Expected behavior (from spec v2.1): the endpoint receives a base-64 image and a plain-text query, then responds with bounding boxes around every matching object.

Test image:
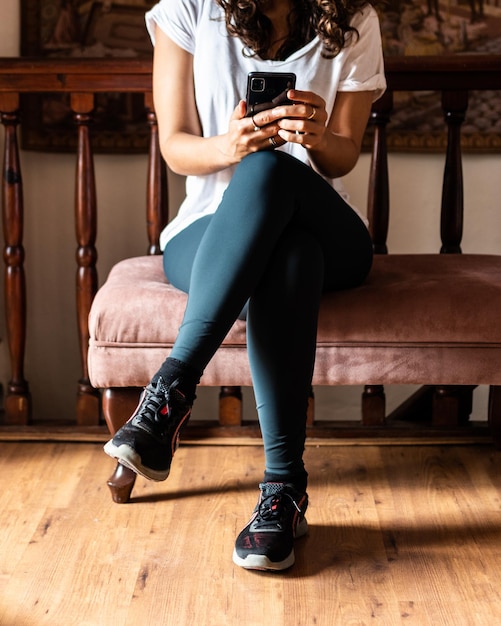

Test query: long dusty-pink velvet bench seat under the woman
[89,255,501,387]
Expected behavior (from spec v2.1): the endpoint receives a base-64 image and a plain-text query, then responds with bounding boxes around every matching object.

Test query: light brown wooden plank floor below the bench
[0,442,501,626]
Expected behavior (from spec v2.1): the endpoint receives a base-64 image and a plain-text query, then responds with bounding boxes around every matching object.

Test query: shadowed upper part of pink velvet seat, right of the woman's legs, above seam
[318,254,501,347]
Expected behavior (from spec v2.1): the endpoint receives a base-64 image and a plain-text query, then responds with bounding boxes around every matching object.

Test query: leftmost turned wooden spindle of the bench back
[0,93,31,424]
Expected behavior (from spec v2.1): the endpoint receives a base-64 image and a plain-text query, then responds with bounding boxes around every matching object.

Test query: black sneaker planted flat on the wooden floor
[233,483,308,571]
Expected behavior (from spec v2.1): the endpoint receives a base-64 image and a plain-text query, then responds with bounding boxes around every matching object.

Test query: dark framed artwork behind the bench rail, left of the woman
[21,0,155,153]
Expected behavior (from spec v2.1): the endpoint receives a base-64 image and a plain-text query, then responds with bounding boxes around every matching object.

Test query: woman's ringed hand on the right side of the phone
[274,89,328,149]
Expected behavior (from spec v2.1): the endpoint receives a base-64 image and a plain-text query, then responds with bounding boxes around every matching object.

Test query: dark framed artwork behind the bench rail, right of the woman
[380,0,501,152]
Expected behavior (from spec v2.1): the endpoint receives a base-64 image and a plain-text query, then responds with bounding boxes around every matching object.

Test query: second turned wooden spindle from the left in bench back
[71,93,100,425]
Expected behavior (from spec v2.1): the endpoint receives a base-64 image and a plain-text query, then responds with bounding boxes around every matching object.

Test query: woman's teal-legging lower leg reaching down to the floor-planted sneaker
[247,226,324,492]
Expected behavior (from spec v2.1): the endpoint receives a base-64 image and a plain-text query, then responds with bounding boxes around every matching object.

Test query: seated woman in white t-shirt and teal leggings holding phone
[105,0,385,570]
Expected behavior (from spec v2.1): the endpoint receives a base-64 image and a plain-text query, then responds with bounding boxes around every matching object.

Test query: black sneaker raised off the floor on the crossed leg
[104,378,191,480]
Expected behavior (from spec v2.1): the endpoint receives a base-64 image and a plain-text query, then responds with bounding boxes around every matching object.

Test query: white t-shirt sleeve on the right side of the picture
[338,7,386,100]
